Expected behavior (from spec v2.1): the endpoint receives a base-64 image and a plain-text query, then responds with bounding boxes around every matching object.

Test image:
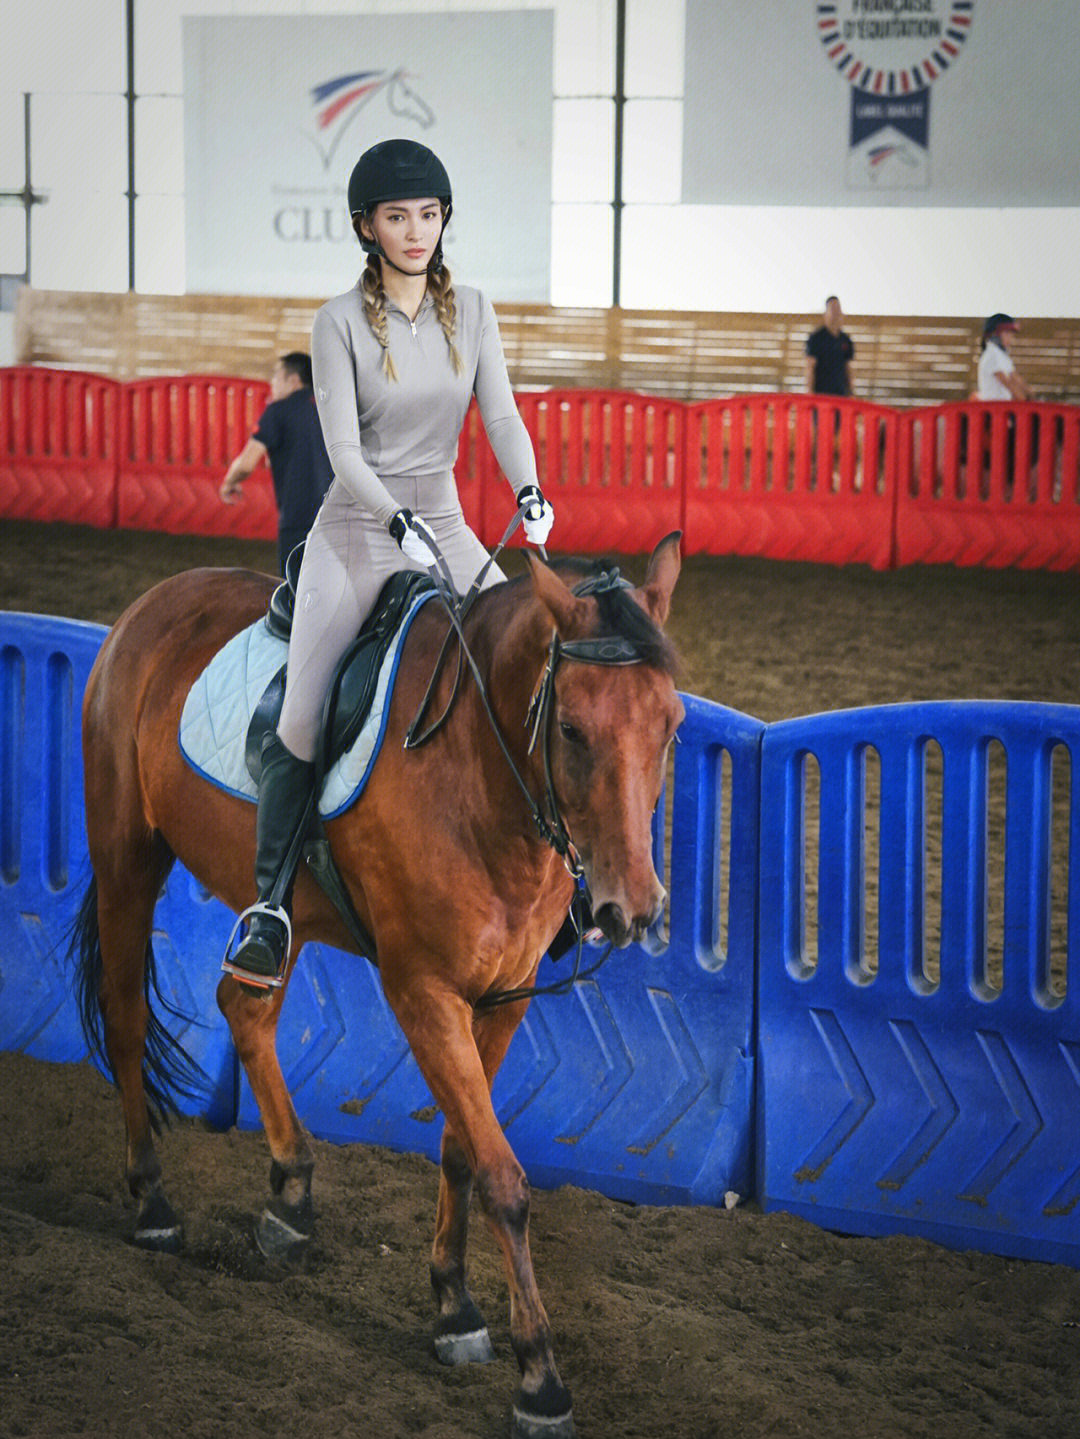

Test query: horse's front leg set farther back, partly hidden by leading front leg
[431,1004,523,1364]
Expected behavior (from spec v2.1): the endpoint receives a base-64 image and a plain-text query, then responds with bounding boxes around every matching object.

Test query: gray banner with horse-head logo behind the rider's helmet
[183,10,554,304]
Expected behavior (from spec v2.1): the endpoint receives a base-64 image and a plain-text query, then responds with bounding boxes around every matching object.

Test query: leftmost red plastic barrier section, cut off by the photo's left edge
[0,366,121,528]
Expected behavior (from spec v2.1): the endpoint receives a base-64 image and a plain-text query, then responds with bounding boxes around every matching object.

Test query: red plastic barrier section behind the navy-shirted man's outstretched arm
[116,376,278,540]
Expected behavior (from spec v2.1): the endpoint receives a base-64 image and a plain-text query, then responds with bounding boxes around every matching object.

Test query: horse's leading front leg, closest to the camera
[383,984,574,1439]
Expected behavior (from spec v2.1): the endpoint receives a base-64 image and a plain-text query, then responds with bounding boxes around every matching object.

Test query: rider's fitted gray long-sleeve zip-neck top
[311,285,536,524]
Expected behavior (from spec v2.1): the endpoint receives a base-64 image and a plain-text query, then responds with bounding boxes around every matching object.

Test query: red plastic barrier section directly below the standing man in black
[685,394,902,570]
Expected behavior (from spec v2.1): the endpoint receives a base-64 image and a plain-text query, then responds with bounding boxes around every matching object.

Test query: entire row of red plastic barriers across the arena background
[0,367,1080,568]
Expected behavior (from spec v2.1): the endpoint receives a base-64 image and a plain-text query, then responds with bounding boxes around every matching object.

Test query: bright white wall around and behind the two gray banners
[0,0,1080,317]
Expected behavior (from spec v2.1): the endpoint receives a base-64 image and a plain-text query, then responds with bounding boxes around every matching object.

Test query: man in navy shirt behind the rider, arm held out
[220,350,334,574]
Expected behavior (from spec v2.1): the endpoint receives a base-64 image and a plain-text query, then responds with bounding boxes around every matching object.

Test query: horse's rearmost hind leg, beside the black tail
[78,835,183,1252]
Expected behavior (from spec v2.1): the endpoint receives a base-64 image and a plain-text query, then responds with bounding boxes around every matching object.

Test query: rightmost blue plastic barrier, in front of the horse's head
[758,702,1080,1265]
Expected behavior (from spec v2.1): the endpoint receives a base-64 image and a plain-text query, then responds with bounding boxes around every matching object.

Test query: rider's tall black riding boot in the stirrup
[221,730,315,989]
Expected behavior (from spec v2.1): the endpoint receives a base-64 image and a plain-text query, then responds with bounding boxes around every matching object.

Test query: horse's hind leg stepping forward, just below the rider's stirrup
[217,967,315,1261]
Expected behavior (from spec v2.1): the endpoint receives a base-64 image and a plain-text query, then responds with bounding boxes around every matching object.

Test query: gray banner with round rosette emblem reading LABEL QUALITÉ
[683,0,1080,207]
